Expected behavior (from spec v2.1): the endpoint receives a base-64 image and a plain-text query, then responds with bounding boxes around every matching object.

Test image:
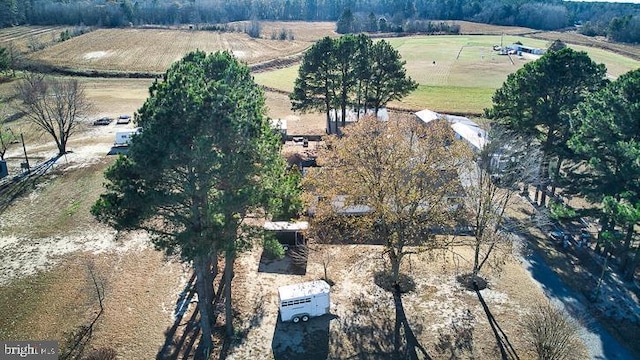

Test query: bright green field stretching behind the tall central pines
[255,35,640,114]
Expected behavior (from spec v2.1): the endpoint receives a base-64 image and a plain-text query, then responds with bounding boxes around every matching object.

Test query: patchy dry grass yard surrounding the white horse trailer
[232,245,544,359]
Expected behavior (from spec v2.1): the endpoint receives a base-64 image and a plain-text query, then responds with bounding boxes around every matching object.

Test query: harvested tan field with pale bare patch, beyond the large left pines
[31,22,336,73]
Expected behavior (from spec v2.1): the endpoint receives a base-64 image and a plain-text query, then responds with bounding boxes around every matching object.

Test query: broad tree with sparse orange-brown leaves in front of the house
[305,117,468,284]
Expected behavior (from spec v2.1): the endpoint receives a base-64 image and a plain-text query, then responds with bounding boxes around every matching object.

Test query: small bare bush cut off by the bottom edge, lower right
[522,302,589,360]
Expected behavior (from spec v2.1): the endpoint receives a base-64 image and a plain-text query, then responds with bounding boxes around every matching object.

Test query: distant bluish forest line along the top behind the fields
[0,0,640,42]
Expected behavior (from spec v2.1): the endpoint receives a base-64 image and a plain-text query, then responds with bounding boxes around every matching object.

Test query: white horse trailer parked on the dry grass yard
[278,280,331,323]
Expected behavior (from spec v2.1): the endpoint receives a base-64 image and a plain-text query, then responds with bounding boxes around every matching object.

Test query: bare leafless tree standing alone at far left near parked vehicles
[16,73,91,155]
